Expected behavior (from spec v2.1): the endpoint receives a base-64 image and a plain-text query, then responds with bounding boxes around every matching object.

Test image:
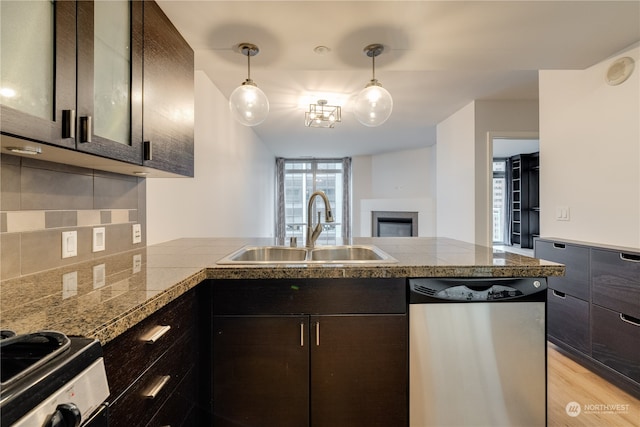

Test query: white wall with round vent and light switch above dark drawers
[540,46,640,248]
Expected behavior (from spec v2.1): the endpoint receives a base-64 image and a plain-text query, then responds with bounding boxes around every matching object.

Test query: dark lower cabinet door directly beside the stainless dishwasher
[310,314,409,427]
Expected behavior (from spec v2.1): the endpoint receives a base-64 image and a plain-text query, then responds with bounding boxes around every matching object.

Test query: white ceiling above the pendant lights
[157,0,640,157]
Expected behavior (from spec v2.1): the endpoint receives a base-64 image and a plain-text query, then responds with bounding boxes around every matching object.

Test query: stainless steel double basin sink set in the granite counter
[218,245,398,264]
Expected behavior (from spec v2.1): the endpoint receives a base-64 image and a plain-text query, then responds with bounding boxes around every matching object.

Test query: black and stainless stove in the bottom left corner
[0,331,109,427]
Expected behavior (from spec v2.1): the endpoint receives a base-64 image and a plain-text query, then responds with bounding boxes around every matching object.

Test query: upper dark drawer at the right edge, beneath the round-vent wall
[591,249,640,317]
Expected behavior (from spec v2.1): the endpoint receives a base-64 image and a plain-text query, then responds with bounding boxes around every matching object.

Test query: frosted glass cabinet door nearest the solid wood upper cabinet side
[76,0,142,164]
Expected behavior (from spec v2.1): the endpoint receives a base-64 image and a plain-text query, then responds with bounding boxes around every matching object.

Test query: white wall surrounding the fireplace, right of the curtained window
[352,147,436,237]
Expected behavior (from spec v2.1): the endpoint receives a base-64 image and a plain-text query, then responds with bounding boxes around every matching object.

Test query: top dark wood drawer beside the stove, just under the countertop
[104,293,195,400]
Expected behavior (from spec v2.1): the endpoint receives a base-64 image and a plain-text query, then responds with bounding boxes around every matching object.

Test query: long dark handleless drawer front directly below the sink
[212,278,407,315]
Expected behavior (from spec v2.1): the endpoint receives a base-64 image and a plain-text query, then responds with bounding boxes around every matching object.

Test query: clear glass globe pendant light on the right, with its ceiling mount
[354,44,393,127]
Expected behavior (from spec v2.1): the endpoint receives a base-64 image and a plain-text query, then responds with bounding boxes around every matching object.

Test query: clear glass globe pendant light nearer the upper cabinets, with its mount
[229,43,269,126]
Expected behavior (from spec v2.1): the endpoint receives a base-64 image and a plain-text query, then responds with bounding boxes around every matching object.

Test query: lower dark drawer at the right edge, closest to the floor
[591,305,640,383]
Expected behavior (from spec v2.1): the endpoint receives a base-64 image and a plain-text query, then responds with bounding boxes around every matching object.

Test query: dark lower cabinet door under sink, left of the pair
[212,316,309,427]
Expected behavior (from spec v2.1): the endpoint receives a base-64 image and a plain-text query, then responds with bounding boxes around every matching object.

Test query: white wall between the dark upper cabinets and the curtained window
[147,71,275,245]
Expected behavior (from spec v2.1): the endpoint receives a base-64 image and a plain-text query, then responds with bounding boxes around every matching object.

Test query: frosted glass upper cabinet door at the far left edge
[0,0,76,148]
